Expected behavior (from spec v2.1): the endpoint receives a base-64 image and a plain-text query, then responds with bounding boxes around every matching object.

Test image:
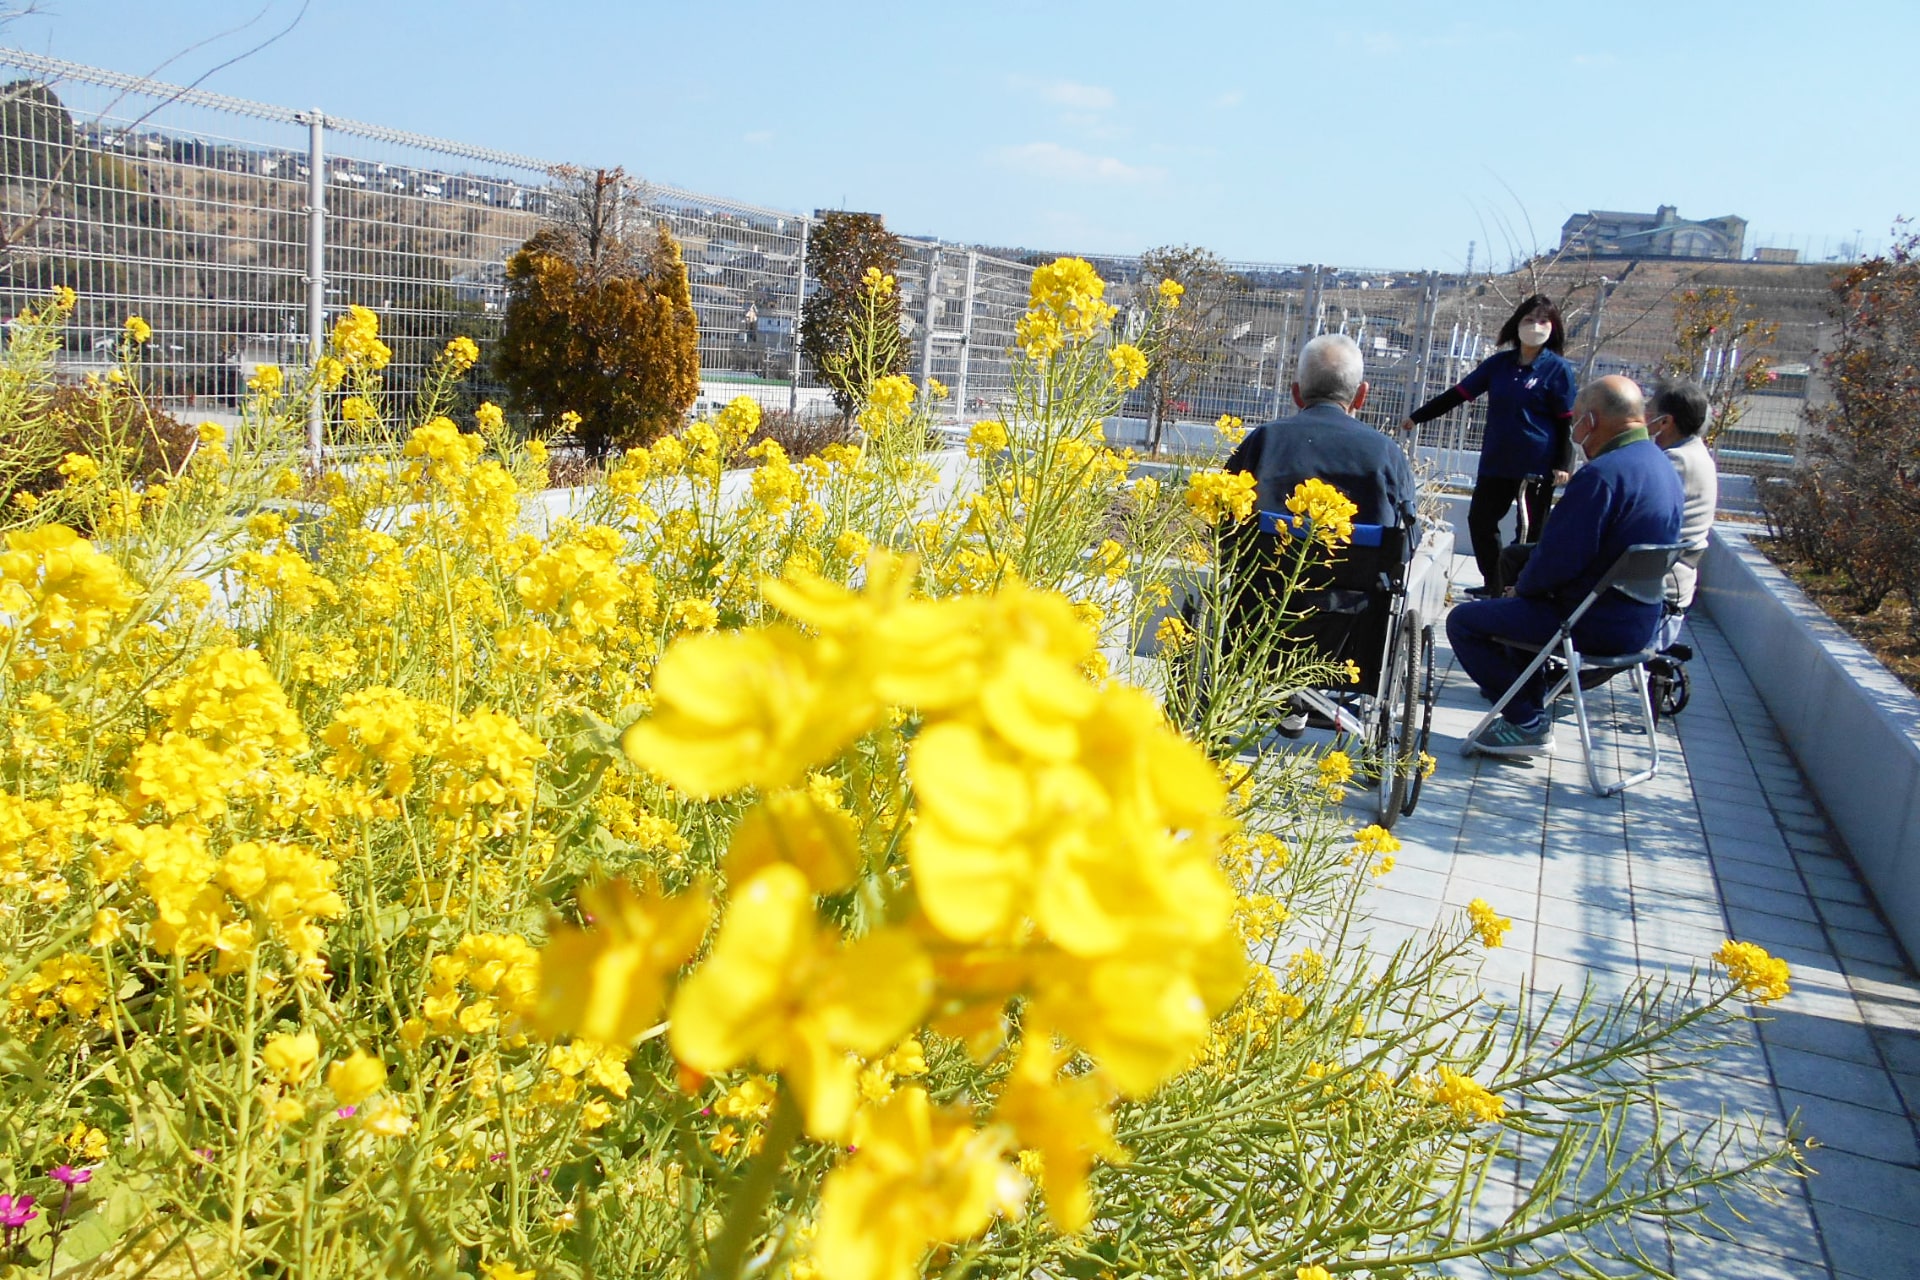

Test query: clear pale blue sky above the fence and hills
[18,0,1920,269]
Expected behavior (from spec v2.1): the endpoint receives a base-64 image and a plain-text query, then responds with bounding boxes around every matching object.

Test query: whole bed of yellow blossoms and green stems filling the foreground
[0,276,1795,1280]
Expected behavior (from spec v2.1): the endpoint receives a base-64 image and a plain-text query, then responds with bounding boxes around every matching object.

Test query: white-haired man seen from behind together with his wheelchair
[1227,334,1444,823]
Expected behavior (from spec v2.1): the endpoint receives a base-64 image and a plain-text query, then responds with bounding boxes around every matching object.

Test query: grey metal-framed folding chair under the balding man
[1461,543,1686,796]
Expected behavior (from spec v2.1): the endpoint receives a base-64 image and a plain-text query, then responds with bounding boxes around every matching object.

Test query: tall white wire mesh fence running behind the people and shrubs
[0,50,1824,495]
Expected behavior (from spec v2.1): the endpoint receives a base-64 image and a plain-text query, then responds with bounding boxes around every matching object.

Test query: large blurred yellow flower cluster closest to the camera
[526,558,1246,1274]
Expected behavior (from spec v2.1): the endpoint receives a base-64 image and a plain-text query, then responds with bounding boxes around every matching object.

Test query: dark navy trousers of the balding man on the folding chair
[1446,595,1661,725]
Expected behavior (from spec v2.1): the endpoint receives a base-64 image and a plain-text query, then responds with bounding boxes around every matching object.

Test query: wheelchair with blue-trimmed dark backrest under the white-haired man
[1229,510,1446,827]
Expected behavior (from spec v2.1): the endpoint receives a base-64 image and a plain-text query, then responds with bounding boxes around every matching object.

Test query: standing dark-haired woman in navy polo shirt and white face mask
[1400,294,1576,595]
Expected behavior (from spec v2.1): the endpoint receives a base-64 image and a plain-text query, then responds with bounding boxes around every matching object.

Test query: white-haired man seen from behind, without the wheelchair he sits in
[1227,334,1419,530]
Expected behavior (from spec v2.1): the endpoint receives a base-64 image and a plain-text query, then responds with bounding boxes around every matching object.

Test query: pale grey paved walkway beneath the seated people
[1361,562,1920,1280]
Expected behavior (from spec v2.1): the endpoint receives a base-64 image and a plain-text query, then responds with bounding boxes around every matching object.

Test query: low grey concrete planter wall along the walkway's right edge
[1699,530,1920,956]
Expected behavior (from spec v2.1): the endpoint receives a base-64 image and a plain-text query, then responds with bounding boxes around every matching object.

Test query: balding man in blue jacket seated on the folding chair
[1446,376,1686,756]
